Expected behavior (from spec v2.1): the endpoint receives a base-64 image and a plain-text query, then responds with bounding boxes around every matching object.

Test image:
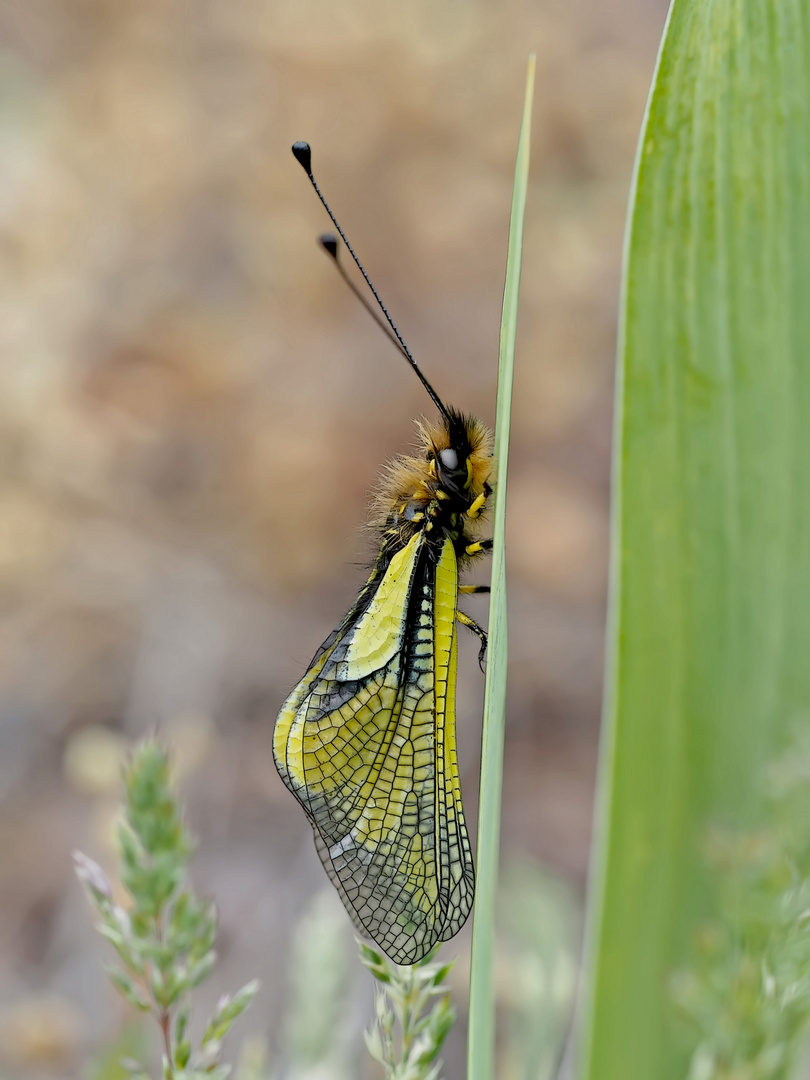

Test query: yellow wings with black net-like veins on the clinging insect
[273,532,474,963]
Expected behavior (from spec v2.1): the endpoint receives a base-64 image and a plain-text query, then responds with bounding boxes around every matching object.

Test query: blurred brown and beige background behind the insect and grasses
[0,0,665,1078]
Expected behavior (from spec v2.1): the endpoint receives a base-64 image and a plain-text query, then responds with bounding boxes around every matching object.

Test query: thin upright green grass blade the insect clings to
[468,55,535,1080]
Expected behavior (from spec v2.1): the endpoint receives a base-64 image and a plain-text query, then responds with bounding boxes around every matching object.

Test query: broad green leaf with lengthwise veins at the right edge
[579,0,810,1080]
